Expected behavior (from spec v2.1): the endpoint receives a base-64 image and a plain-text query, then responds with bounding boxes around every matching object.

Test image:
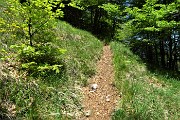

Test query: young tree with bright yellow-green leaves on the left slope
[0,0,65,74]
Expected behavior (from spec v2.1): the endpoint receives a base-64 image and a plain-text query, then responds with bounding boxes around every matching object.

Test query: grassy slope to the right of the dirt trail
[111,42,180,120]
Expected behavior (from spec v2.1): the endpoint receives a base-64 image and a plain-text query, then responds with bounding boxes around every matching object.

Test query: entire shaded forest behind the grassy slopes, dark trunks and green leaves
[60,0,180,71]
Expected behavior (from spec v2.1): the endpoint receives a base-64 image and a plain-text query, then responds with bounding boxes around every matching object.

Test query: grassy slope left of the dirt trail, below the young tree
[0,21,102,120]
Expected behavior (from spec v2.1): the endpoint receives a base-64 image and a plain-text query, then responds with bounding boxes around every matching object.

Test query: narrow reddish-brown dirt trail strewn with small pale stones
[81,46,118,120]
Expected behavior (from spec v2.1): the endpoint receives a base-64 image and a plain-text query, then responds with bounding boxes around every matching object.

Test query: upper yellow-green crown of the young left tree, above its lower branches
[5,0,63,46]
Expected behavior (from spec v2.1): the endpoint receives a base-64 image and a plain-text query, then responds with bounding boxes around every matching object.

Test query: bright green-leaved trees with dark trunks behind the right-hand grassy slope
[116,0,180,71]
